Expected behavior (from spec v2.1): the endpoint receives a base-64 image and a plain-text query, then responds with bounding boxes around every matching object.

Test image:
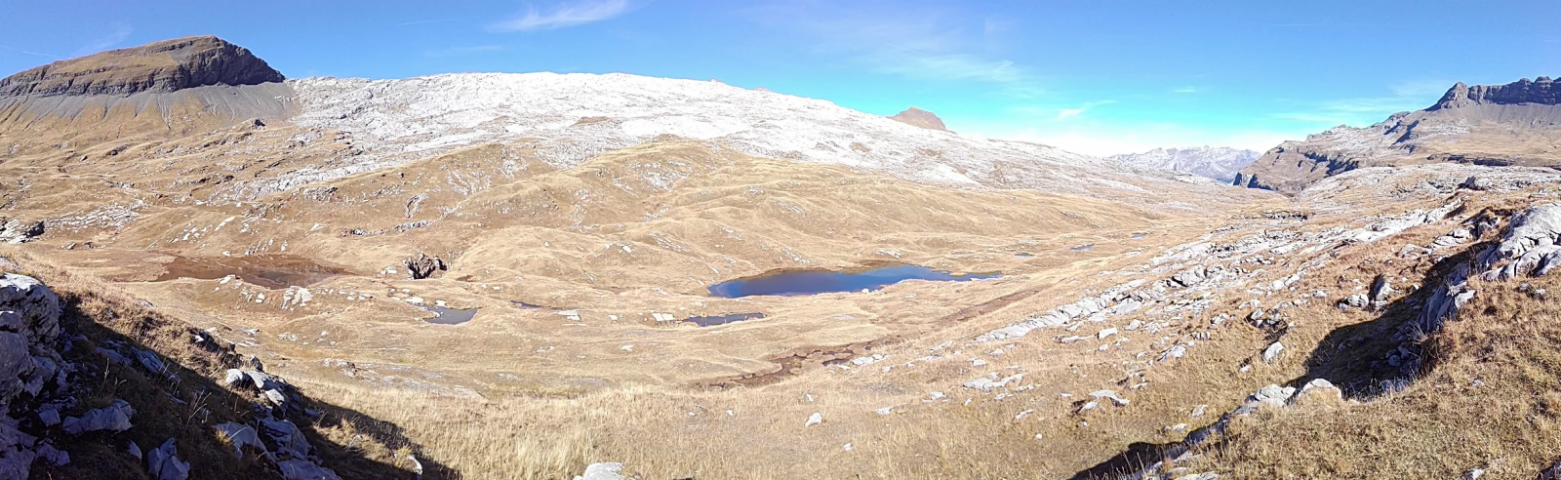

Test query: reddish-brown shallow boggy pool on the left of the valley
[156,255,345,288]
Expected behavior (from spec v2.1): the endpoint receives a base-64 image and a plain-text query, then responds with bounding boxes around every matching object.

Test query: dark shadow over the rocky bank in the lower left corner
[31,291,460,480]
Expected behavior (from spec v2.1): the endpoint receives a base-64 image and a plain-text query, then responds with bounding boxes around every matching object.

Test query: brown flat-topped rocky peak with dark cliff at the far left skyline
[0,36,286,97]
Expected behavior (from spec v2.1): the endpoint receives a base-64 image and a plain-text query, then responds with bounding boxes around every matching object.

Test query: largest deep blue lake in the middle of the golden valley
[710,264,1002,299]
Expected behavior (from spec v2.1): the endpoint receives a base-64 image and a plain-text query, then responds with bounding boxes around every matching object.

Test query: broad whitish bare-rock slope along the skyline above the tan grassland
[280,73,1169,192]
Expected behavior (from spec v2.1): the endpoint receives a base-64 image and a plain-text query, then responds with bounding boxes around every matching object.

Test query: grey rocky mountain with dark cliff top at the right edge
[1235,77,1561,192]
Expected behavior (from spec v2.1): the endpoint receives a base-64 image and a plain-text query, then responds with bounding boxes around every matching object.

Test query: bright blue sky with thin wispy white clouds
[0,0,1561,153]
